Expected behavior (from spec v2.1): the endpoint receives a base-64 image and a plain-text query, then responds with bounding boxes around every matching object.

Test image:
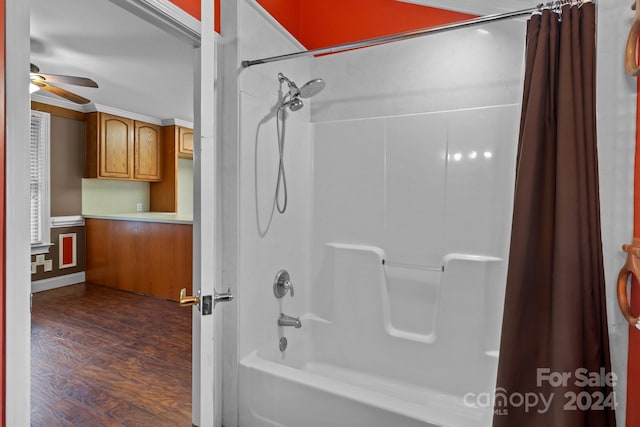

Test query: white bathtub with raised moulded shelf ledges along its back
[239,244,505,427]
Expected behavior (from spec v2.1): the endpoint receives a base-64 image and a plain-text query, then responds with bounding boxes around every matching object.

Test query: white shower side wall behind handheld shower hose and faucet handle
[238,1,311,364]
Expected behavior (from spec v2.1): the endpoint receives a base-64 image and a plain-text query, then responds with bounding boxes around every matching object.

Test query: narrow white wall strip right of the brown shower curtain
[596,1,636,426]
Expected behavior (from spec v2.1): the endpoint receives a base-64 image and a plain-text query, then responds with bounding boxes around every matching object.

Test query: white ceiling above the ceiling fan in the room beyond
[30,0,194,122]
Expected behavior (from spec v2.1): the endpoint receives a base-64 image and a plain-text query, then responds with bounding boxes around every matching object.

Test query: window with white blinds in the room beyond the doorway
[30,111,51,254]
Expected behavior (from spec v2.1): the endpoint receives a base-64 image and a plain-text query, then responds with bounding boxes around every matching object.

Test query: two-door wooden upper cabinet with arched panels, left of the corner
[85,112,162,181]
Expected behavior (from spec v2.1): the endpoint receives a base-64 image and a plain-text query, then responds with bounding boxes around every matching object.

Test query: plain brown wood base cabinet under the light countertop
[85,218,193,301]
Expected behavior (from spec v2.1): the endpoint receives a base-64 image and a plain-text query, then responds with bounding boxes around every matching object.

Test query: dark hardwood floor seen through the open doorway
[31,284,191,427]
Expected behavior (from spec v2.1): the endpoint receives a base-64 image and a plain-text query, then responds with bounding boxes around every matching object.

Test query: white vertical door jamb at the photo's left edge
[4,0,31,426]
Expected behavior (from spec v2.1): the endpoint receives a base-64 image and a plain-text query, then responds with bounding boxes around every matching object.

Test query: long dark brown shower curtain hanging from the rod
[493,3,622,427]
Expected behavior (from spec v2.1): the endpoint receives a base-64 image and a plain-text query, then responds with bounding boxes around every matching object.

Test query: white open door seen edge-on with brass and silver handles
[192,0,224,427]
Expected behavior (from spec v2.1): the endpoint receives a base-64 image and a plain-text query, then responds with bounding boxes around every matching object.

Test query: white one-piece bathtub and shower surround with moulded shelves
[238,26,520,427]
